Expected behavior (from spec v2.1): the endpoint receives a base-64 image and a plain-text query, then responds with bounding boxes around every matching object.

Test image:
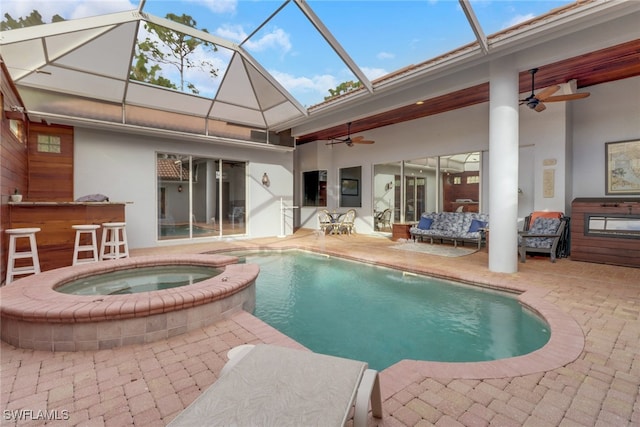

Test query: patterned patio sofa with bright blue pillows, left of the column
[409,212,489,248]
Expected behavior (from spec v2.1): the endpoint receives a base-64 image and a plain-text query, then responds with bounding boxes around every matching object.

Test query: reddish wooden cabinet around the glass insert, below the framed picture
[570,198,640,267]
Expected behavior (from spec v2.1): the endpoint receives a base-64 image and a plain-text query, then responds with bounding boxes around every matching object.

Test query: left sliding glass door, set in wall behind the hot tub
[156,153,246,240]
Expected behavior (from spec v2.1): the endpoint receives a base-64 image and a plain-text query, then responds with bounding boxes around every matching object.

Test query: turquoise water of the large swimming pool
[233,251,550,370]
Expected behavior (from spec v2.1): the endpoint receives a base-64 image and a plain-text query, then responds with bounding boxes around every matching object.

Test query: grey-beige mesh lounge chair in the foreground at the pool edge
[169,344,382,427]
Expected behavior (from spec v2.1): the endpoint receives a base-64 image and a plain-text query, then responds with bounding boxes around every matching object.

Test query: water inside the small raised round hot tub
[55,265,222,295]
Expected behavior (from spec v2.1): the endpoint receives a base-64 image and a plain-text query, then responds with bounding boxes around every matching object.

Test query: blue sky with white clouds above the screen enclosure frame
[0,0,572,107]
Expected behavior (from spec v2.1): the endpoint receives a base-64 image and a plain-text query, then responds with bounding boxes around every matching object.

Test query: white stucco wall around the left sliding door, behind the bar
[74,127,293,248]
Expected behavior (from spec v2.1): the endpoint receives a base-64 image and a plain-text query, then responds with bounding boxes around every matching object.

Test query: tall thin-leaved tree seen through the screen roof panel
[131,13,218,94]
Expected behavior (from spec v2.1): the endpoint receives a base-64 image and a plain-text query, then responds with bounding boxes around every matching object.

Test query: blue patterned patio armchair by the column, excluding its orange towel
[518,216,565,262]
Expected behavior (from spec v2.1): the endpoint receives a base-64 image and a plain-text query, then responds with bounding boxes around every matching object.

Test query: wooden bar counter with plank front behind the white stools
[9,202,127,271]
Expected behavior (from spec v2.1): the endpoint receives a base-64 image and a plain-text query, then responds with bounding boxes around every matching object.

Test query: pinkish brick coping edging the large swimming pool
[211,245,585,397]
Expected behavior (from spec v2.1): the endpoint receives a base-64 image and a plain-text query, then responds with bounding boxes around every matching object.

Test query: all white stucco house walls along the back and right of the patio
[74,77,640,248]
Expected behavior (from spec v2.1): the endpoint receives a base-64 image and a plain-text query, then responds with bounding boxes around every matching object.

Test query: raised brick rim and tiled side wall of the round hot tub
[0,254,259,351]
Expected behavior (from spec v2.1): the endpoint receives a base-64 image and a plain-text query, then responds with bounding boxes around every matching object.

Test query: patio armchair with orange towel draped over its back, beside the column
[518,212,569,262]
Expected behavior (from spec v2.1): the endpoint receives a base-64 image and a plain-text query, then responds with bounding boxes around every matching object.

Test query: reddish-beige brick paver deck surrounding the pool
[0,230,640,427]
